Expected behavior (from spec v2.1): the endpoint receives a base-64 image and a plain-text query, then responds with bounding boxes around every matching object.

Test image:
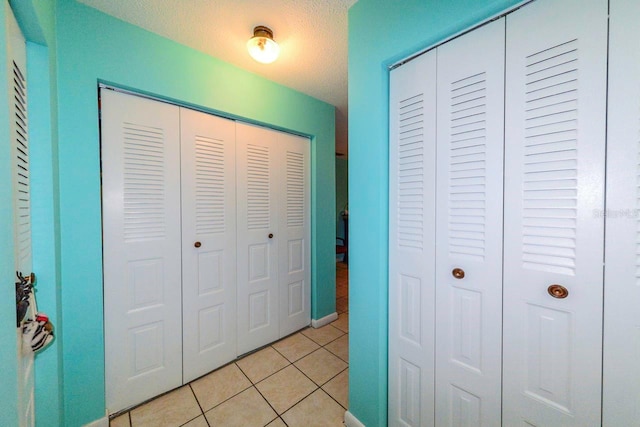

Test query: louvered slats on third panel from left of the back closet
[247,144,271,230]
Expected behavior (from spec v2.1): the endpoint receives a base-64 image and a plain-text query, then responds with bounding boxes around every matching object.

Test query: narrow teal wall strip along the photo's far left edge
[0,1,18,426]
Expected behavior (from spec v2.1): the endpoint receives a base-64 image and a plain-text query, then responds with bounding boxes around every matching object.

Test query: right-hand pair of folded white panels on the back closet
[236,123,311,355]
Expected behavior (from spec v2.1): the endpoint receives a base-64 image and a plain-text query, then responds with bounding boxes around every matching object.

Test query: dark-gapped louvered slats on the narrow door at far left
[13,62,31,265]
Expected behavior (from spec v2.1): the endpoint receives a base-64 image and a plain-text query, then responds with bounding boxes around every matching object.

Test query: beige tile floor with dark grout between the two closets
[110,262,349,427]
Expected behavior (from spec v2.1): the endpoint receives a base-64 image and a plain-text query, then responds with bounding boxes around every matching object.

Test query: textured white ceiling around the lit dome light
[78,0,357,154]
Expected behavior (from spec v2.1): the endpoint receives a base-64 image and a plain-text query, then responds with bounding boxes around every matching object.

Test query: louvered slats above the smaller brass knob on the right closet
[449,73,487,261]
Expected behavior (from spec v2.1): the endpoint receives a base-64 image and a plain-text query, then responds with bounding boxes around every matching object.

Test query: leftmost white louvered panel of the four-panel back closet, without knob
[101,90,182,413]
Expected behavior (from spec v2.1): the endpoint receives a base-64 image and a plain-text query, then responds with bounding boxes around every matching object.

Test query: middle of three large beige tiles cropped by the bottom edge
[205,387,278,427]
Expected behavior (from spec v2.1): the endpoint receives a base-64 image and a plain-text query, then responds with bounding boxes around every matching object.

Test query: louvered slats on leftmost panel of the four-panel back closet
[122,123,166,241]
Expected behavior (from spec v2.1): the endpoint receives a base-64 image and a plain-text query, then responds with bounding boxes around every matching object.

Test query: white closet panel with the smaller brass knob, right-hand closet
[435,19,504,427]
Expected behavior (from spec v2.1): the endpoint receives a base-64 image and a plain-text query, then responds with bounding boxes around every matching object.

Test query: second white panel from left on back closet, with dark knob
[180,108,236,382]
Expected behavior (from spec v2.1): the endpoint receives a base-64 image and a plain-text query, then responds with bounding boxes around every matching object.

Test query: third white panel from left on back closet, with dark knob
[236,123,280,354]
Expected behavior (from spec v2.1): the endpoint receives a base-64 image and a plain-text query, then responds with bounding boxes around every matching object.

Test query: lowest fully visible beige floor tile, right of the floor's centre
[256,365,317,414]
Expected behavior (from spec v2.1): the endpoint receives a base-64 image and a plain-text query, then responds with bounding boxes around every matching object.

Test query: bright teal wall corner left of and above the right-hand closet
[349,0,518,427]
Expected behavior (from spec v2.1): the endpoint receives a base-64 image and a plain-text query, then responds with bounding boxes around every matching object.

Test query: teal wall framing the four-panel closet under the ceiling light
[56,0,335,426]
